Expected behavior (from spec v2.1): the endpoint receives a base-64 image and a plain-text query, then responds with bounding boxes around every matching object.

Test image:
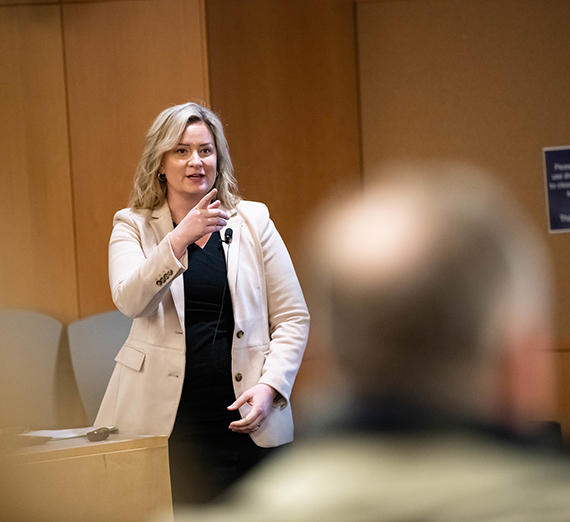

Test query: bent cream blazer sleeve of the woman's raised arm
[109,209,187,318]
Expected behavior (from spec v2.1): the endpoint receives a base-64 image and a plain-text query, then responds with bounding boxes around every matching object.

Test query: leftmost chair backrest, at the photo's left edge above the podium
[0,310,63,429]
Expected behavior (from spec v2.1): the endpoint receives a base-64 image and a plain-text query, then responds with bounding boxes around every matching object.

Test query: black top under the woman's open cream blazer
[174,232,239,436]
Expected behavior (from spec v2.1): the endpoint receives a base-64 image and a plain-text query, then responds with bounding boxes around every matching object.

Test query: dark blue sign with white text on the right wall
[542,147,570,232]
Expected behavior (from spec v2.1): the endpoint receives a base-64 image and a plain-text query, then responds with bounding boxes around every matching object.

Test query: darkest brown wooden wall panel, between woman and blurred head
[206,0,361,410]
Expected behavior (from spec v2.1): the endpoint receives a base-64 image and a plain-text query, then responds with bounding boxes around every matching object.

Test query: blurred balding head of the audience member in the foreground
[312,167,549,422]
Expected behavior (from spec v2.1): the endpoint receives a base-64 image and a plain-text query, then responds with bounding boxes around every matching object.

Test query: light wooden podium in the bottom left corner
[2,434,172,522]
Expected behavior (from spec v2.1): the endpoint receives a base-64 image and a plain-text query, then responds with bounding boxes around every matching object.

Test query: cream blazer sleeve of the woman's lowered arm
[252,205,309,408]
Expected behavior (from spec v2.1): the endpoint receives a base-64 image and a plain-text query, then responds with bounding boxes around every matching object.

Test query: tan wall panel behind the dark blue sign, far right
[357,0,570,338]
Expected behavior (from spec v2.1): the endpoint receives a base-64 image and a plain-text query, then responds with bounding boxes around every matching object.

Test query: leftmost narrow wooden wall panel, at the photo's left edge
[0,6,78,322]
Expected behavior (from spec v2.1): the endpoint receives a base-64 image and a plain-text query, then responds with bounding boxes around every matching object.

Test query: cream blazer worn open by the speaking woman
[95,201,309,447]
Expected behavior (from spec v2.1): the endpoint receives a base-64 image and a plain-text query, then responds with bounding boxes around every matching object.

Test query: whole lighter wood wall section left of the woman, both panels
[0,0,209,323]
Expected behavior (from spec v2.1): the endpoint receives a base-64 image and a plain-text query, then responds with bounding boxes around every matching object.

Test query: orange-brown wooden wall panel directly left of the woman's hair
[63,0,208,317]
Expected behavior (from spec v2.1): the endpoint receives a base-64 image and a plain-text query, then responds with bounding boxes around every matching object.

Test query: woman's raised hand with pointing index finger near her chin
[168,189,230,259]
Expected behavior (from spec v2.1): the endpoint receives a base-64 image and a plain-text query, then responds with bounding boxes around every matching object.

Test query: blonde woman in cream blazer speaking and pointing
[96,103,309,502]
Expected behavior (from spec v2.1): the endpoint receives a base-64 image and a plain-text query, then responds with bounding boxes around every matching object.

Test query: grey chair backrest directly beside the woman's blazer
[67,311,132,423]
